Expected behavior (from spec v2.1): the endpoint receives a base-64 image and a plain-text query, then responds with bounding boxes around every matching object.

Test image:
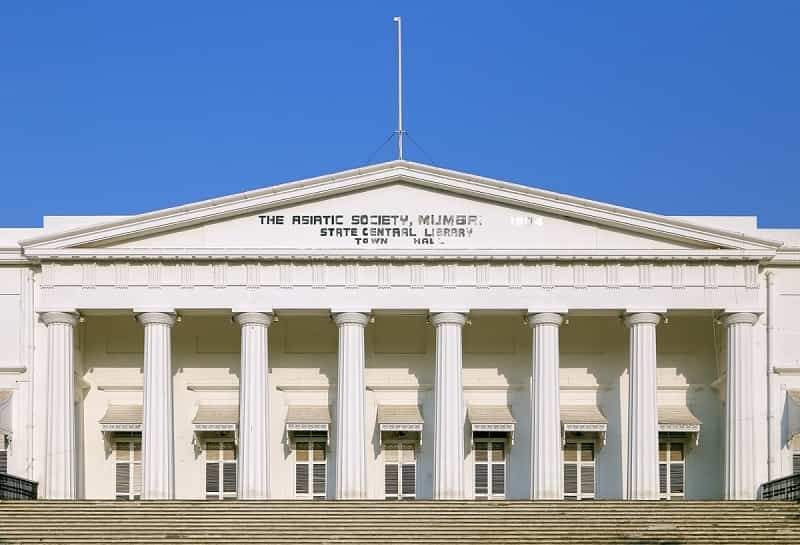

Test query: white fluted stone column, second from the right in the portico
[625,312,661,500]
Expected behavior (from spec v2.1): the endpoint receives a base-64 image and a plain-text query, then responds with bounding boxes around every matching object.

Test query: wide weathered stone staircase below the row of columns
[0,501,800,545]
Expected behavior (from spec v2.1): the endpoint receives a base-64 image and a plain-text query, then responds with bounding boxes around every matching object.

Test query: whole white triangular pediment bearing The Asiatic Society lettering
[23,161,779,255]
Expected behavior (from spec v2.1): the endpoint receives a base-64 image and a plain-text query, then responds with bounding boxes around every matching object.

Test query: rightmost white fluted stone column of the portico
[722,312,758,500]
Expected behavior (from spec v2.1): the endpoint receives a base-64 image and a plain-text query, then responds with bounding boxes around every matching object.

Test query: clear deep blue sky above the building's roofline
[0,0,800,227]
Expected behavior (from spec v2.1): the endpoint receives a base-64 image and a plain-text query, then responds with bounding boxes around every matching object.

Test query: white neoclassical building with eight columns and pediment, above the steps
[0,161,800,500]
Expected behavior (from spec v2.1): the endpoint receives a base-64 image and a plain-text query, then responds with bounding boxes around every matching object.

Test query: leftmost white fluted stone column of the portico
[41,312,78,500]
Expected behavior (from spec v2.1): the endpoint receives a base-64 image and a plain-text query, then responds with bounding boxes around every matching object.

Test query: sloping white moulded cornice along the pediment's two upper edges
[21,161,782,255]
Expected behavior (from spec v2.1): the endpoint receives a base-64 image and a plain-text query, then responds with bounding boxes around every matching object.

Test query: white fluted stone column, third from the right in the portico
[528,312,564,500]
